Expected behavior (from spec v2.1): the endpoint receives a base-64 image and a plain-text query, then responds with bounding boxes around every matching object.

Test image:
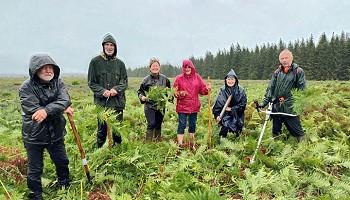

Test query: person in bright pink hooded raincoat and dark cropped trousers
[174,60,211,147]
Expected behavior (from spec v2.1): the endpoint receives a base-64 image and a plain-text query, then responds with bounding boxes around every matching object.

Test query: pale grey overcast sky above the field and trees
[0,0,350,74]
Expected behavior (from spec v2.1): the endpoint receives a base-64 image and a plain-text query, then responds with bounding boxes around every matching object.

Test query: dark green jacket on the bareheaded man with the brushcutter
[261,63,306,114]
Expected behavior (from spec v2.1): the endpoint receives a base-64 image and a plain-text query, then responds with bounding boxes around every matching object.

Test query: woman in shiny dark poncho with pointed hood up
[213,69,247,143]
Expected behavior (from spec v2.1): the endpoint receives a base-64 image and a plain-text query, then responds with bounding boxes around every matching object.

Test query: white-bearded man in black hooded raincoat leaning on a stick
[19,54,74,199]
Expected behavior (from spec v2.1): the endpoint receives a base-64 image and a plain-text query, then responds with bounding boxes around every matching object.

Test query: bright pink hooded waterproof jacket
[174,60,208,114]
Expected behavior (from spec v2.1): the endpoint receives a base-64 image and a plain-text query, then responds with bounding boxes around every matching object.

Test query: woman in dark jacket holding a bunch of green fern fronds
[137,58,171,141]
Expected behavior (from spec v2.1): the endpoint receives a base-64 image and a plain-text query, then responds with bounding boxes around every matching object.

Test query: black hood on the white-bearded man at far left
[29,54,60,79]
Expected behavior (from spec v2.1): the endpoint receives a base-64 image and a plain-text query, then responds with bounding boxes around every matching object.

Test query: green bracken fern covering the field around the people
[0,77,350,200]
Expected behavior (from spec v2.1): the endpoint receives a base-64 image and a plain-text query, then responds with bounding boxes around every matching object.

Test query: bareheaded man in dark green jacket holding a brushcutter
[258,50,306,141]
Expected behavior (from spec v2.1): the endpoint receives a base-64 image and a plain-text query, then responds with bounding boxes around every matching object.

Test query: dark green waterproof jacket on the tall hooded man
[88,52,128,110]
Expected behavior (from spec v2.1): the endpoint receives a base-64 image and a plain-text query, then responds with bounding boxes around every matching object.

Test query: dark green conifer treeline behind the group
[128,32,350,80]
